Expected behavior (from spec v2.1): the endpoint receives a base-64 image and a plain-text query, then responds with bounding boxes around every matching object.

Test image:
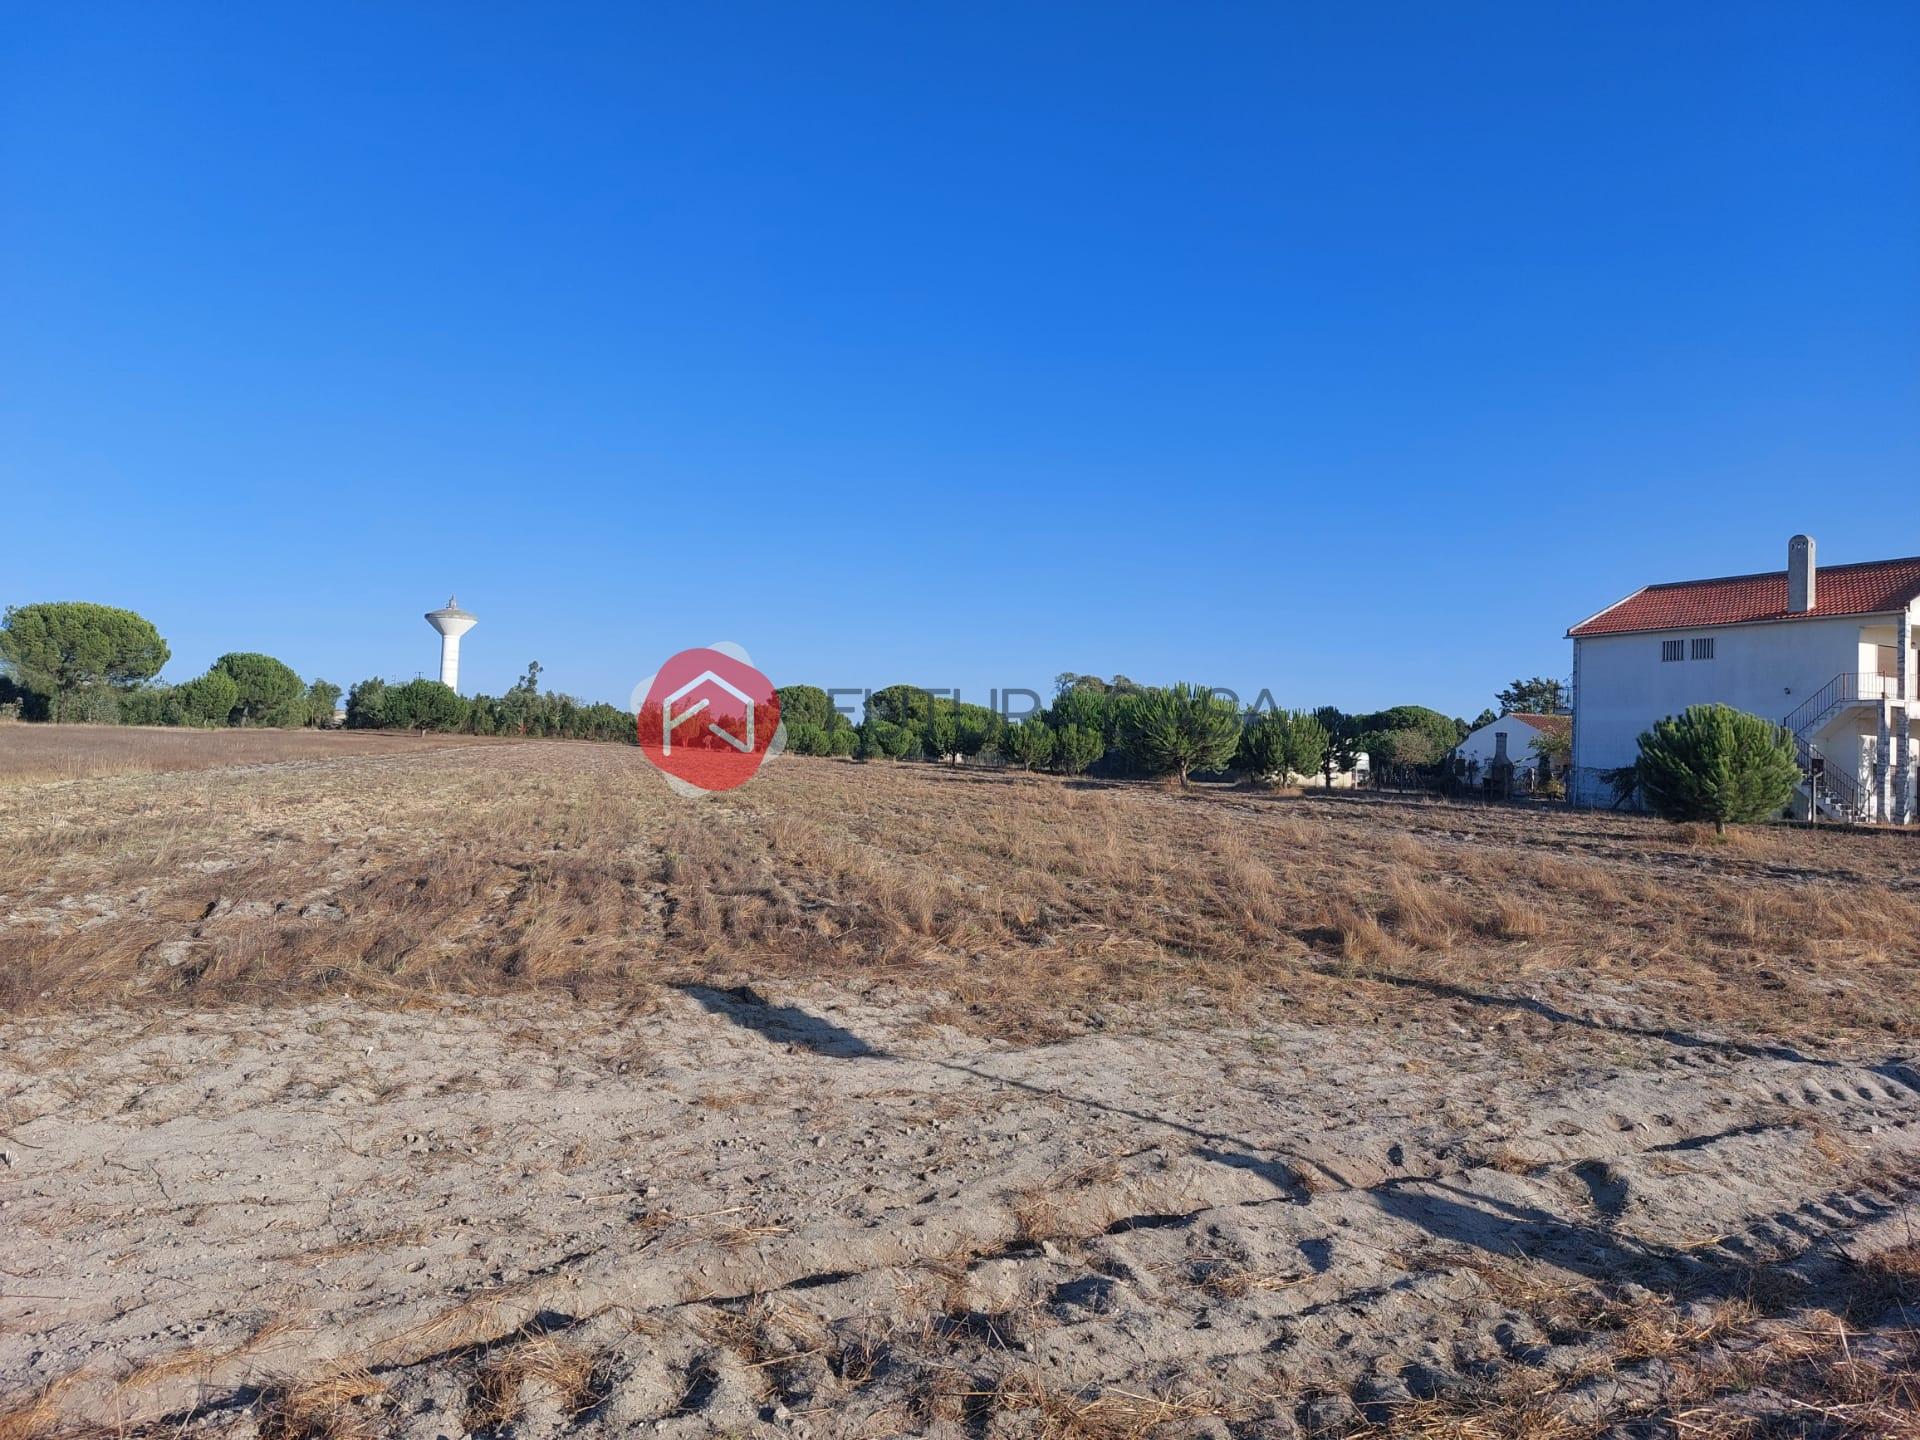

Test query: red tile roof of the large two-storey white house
[1567,555,1920,639]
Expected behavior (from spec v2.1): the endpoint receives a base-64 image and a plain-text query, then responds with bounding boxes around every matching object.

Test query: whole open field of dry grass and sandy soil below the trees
[0,726,1920,1440]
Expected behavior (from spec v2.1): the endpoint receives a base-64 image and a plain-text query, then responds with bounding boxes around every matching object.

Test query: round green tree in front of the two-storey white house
[1636,705,1801,833]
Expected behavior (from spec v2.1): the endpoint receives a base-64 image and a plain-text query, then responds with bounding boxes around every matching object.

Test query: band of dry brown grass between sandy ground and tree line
[0,728,1920,1043]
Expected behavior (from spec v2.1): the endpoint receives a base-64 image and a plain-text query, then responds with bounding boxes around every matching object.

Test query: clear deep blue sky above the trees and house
[0,0,1920,714]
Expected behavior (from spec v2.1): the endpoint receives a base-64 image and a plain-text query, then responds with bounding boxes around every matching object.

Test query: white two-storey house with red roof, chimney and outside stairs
[1567,536,1920,824]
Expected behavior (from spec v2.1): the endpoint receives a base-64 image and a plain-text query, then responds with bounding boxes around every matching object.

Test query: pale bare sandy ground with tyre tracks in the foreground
[0,987,1920,1440]
